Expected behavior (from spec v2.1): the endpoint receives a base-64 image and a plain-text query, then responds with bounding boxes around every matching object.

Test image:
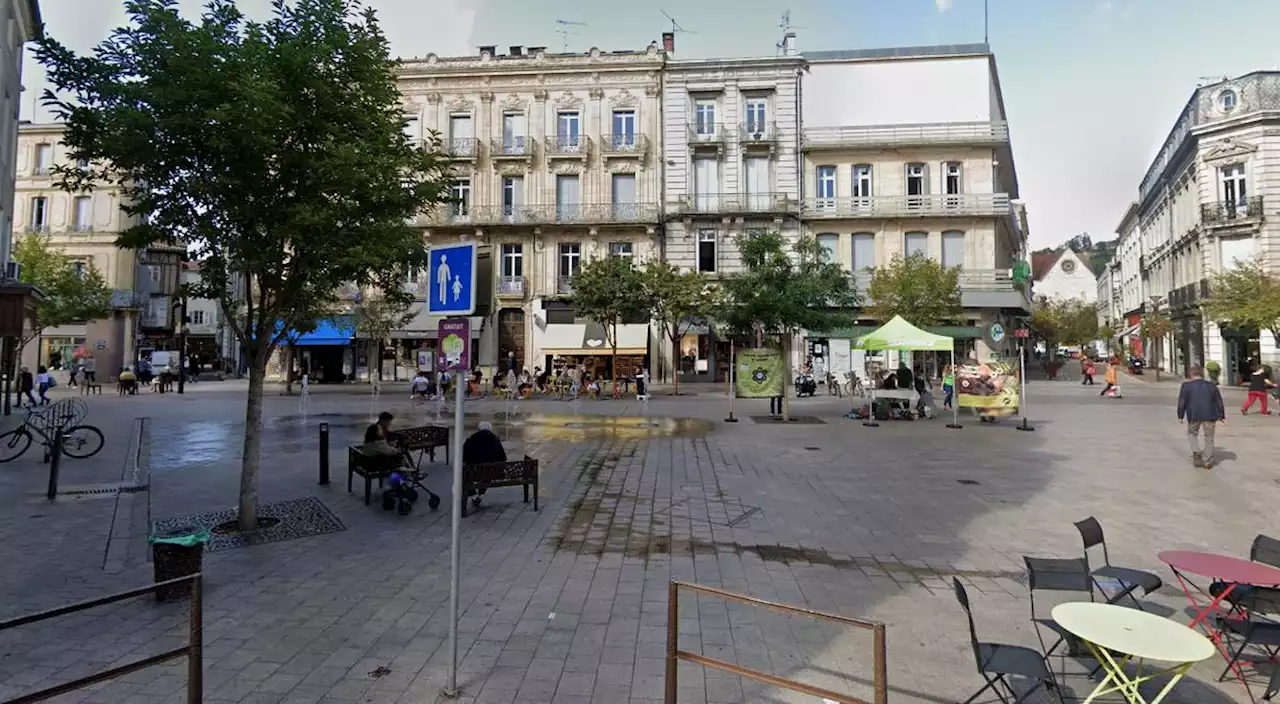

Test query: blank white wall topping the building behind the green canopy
[801,56,1005,127]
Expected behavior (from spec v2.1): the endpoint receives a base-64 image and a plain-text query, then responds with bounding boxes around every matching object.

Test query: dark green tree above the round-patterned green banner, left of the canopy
[719,232,861,420]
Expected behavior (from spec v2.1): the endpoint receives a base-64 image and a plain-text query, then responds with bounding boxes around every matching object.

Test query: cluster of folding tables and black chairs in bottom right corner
[952,517,1280,704]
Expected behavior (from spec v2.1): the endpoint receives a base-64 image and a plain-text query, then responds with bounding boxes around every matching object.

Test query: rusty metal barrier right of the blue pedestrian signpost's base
[666,580,888,704]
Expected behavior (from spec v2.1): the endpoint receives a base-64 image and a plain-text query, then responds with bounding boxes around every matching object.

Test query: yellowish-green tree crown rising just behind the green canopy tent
[867,253,964,326]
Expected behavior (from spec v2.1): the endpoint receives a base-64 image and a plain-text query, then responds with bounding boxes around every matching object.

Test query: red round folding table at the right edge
[1156,550,1280,698]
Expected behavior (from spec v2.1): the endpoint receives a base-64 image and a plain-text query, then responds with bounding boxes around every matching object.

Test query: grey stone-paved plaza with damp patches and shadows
[0,373,1280,704]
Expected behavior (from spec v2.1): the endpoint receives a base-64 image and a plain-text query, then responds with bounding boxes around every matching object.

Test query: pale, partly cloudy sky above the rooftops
[23,0,1280,248]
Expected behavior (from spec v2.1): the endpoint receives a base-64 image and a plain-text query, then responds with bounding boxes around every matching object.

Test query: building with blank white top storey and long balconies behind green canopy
[800,45,1029,369]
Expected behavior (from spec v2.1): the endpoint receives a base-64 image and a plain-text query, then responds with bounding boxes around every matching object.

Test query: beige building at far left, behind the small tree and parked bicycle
[12,123,153,370]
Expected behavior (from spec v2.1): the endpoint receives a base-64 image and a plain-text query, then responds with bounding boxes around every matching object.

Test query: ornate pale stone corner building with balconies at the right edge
[1137,70,1280,383]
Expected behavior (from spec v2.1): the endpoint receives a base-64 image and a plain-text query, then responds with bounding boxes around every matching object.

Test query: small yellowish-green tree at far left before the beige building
[9,234,111,358]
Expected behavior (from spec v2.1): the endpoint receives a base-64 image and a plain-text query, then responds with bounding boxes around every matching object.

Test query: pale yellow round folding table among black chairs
[1051,602,1213,704]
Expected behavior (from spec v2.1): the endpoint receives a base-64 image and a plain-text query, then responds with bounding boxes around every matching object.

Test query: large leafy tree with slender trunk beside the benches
[36,0,452,531]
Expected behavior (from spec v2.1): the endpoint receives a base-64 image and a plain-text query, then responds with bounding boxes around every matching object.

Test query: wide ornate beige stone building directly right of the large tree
[399,44,666,378]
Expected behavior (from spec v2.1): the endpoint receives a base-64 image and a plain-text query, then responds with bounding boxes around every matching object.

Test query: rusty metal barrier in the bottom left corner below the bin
[0,572,204,704]
